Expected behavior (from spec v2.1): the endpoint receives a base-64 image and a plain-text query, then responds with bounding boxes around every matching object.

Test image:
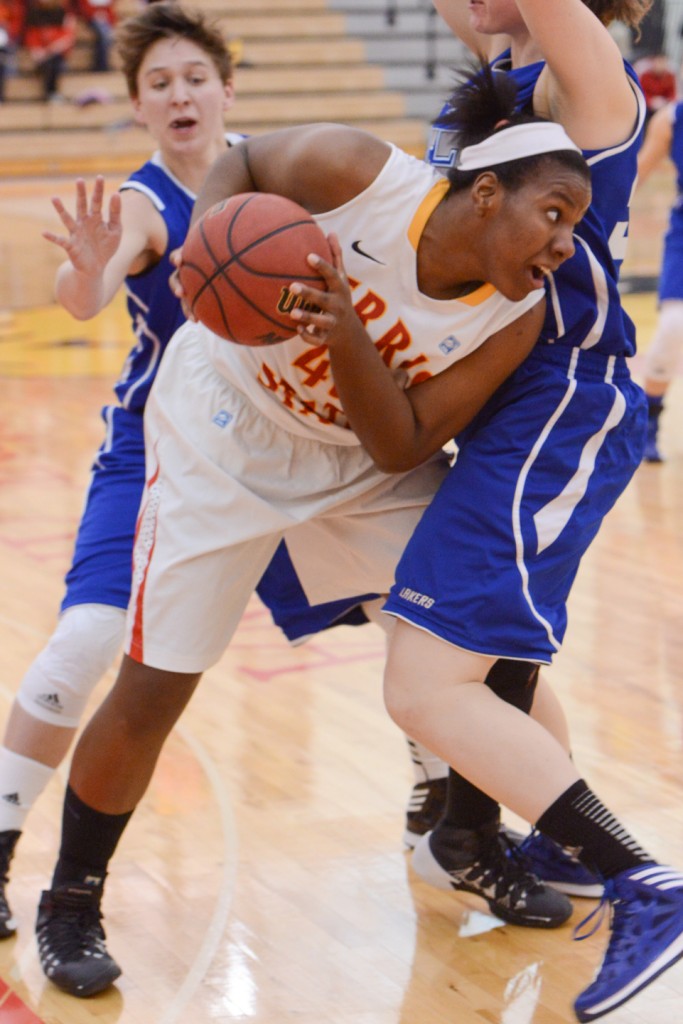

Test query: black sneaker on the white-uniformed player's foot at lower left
[36,885,121,998]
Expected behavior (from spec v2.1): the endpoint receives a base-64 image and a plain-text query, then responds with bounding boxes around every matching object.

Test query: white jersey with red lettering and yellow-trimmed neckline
[200,146,545,444]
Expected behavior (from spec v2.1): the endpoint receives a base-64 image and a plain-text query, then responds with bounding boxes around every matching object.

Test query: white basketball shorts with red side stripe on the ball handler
[126,324,447,673]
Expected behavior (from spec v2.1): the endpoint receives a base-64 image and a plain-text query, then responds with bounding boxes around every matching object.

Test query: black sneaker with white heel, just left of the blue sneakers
[413,821,572,928]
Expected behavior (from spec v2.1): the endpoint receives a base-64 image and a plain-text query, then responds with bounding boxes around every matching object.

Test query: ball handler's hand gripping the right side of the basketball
[290,234,360,347]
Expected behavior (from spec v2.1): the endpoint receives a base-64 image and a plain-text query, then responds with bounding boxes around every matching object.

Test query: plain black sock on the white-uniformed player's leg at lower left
[52,785,133,889]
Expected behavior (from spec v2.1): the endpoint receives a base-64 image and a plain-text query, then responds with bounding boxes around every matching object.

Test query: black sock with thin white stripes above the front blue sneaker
[537,778,654,879]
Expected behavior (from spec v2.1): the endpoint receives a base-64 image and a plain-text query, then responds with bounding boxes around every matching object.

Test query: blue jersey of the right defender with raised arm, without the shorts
[427,50,645,364]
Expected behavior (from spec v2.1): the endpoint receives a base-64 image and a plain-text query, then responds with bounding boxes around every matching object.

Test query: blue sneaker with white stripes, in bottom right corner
[573,864,683,1021]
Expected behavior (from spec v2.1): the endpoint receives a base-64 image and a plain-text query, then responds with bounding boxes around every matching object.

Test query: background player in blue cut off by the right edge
[638,100,683,463]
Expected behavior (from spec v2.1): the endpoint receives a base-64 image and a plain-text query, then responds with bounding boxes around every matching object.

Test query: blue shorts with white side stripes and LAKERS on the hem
[385,344,646,664]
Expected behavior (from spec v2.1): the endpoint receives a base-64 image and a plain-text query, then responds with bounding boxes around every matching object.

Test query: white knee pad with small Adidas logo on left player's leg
[16,604,126,728]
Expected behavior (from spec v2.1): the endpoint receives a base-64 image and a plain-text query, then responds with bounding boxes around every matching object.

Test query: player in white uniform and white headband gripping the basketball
[37,56,590,996]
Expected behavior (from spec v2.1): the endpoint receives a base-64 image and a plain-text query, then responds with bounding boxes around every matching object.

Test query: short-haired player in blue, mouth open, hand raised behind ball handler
[0,3,242,938]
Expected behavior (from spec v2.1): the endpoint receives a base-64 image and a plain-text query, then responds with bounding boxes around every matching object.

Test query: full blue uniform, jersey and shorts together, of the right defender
[385,51,647,663]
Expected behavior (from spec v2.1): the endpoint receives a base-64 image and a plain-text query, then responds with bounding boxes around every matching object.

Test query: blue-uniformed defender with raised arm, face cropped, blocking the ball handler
[302,0,683,1021]
